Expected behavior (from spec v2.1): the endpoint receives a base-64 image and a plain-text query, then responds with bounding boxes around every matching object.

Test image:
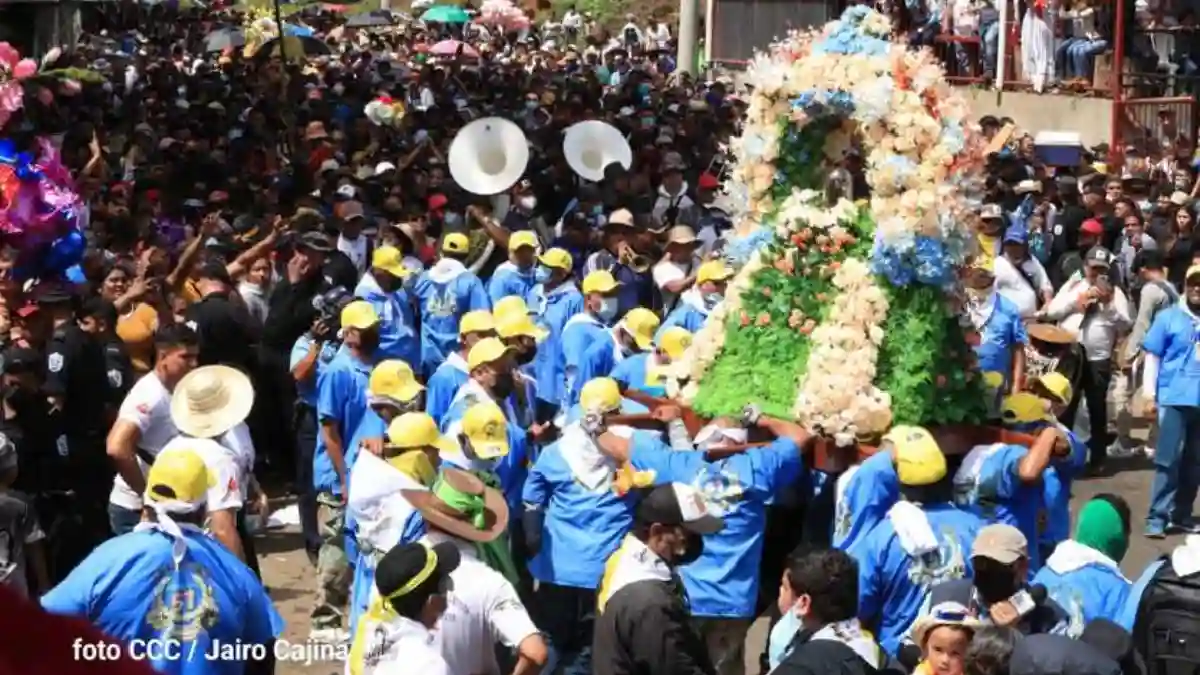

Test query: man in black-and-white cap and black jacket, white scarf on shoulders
[592,483,725,675]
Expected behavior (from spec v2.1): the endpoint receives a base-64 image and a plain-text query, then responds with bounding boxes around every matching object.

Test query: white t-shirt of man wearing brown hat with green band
[432,539,538,675]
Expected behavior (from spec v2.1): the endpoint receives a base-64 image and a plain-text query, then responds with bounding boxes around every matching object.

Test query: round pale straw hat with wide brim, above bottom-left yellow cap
[170,365,254,438]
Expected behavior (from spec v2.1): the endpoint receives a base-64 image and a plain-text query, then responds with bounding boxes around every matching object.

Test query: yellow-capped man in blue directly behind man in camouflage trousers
[354,246,421,370]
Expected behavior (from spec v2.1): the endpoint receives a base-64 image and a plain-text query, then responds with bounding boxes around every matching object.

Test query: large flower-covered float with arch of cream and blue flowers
[668,6,1003,454]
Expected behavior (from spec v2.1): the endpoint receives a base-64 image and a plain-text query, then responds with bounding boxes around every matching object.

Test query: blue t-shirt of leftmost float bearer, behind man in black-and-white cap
[522,441,635,589]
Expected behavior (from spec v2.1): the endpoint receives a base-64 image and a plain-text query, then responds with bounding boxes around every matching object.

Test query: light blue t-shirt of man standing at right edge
[1141,300,1200,407]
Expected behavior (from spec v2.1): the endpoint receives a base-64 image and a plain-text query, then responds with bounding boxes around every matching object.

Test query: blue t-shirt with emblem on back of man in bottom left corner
[42,525,283,675]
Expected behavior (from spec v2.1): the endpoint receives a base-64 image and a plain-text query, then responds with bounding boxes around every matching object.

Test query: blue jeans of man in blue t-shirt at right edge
[1146,406,1200,532]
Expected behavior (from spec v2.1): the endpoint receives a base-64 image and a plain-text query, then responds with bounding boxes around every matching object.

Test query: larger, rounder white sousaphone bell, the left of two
[449,118,529,196]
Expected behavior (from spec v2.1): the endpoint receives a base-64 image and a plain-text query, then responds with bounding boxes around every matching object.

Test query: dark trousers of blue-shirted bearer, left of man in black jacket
[529,583,596,675]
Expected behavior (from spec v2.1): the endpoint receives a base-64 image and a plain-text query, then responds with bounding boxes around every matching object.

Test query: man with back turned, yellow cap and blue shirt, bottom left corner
[42,450,283,675]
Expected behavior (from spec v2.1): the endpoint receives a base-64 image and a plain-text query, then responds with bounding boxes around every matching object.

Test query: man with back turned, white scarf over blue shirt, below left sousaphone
[413,232,492,374]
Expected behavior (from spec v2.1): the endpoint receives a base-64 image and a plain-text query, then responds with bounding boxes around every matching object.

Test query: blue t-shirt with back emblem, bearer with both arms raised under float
[630,434,804,619]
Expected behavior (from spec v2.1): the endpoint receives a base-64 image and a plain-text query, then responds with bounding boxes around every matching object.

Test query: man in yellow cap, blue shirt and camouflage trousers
[312,300,379,643]
